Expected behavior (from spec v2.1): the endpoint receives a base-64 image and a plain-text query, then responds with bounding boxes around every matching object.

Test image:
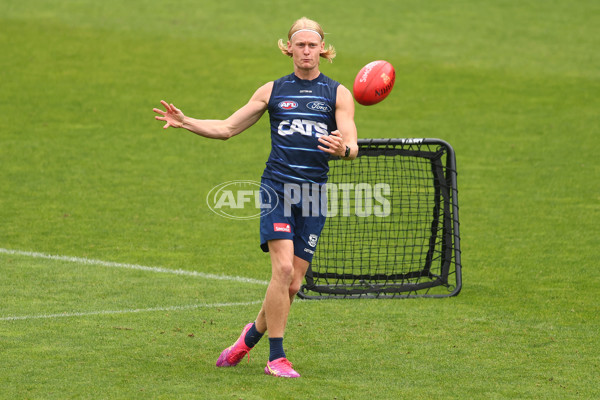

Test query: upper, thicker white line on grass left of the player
[0,248,269,285]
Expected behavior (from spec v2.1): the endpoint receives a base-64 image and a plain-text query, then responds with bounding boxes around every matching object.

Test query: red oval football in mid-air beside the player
[352,60,396,106]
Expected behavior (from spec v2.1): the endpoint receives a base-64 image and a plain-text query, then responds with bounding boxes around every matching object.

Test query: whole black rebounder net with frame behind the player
[298,139,462,299]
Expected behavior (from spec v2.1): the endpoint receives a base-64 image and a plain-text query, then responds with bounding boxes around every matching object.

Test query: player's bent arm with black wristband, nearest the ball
[318,85,358,160]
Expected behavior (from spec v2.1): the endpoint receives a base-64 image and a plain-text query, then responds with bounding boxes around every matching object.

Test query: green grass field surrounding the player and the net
[0,0,600,399]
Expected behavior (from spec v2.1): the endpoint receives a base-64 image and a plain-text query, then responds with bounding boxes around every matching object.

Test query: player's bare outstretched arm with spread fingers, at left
[154,82,273,140]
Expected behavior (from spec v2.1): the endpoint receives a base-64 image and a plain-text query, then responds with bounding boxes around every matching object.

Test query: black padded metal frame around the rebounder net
[298,138,462,299]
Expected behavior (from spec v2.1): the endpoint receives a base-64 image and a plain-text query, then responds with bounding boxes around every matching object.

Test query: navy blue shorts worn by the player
[260,178,327,262]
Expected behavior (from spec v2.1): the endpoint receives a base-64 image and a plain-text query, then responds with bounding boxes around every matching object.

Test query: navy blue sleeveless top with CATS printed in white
[262,74,339,184]
